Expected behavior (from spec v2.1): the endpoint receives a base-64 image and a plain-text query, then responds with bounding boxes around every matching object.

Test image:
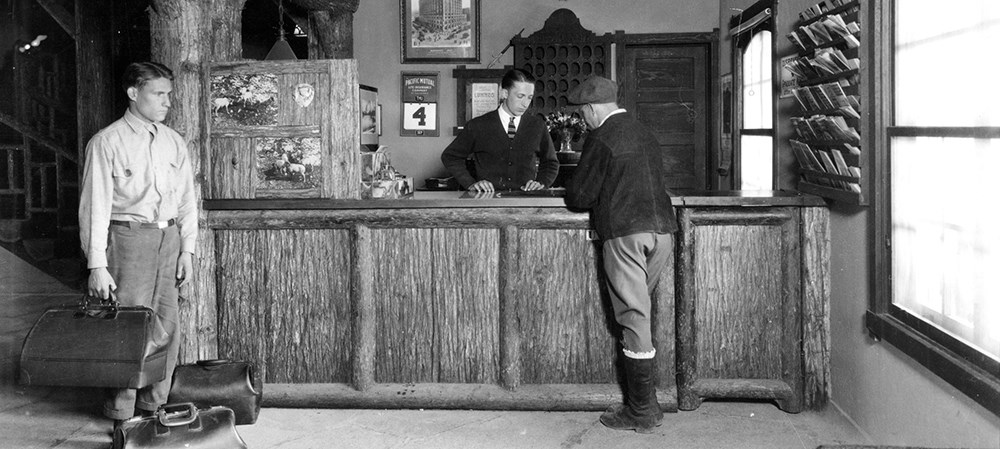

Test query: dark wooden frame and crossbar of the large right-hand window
[862,0,1000,416]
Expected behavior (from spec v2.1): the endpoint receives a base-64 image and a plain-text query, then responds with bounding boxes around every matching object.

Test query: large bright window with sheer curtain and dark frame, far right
[869,0,1000,414]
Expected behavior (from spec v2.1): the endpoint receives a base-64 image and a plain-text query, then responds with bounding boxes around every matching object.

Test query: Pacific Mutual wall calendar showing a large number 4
[399,72,439,137]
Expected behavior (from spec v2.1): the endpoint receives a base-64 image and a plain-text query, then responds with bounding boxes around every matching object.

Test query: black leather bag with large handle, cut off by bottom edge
[111,402,247,449]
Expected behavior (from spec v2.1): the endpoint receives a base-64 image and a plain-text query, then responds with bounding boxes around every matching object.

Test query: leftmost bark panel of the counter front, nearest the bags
[215,229,352,382]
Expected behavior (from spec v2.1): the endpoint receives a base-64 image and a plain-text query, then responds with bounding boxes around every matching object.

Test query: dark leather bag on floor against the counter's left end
[167,359,264,425]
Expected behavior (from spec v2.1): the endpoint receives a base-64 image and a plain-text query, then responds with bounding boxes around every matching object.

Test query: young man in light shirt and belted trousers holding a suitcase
[79,62,198,425]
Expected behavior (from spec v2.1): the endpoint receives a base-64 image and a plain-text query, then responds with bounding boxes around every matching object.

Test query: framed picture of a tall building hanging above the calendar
[399,0,480,64]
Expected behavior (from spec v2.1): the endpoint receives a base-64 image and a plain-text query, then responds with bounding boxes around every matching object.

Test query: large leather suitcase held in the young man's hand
[20,300,170,388]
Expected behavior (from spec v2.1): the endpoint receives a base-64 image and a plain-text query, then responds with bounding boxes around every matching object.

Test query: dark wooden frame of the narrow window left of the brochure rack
[729,0,780,189]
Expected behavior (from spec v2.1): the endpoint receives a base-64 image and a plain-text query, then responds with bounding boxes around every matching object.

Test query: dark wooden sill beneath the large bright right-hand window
[865,311,1000,416]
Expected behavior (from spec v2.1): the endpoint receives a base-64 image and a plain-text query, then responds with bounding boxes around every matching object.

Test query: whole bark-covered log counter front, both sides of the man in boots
[206,192,828,411]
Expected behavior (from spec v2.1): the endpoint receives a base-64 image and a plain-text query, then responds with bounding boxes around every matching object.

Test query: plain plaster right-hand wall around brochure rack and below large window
[718,0,1000,448]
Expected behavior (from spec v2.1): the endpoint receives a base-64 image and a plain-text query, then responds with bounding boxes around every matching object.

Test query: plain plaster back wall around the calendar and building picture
[354,0,719,188]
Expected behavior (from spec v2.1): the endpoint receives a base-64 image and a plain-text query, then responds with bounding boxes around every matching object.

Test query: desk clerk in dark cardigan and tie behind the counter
[441,69,559,192]
